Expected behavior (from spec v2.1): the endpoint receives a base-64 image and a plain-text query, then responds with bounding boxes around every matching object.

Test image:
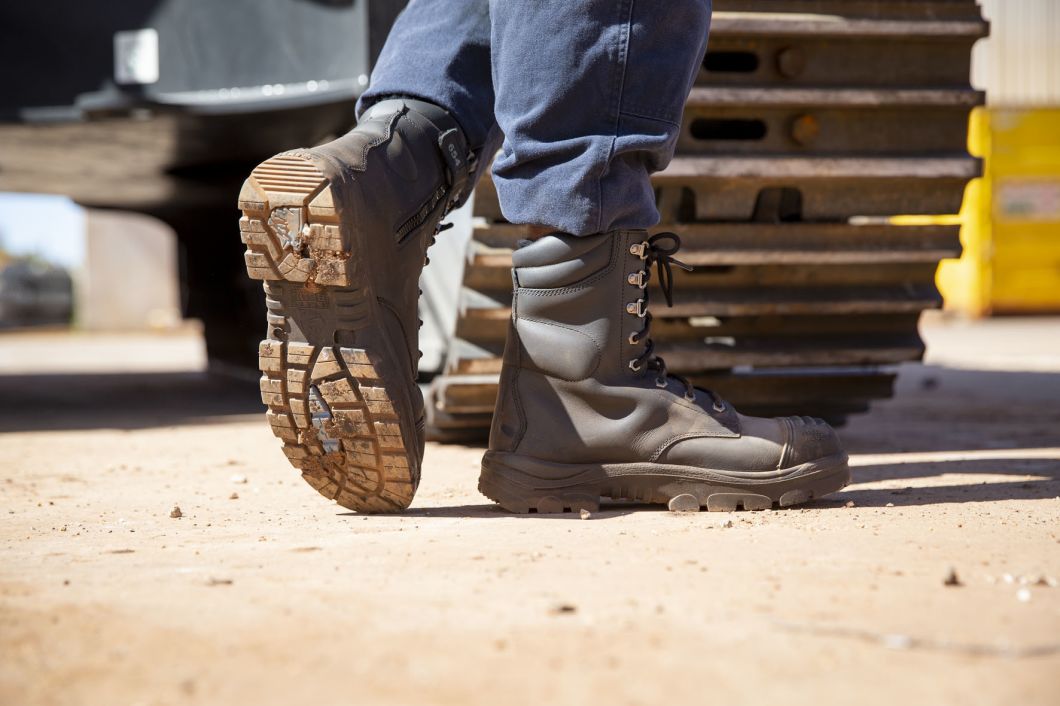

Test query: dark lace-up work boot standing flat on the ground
[479,230,850,512]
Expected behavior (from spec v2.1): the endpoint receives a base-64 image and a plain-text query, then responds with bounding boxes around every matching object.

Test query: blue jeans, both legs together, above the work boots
[358,0,710,235]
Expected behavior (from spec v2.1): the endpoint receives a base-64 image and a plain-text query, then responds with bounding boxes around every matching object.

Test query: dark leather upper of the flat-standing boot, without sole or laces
[490,230,840,472]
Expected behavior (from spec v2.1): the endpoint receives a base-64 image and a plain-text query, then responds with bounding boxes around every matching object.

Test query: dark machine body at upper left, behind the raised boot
[0,0,404,368]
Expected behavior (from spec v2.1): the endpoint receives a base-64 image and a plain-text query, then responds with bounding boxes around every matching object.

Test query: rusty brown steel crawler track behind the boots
[430,0,987,438]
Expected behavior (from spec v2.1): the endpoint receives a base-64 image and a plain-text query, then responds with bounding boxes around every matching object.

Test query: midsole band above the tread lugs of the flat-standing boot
[482,452,847,490]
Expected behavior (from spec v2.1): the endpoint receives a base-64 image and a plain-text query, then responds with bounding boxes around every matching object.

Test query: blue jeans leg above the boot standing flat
[490,0,710,235]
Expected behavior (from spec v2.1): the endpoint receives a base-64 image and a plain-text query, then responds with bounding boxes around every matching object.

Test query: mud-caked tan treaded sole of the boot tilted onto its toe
[239,154,422,512]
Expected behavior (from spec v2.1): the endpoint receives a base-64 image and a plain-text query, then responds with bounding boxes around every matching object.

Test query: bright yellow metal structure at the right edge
[938,108,1060,316]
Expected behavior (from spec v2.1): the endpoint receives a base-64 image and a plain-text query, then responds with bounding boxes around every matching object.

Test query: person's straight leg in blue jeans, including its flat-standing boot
[479,0,850,512]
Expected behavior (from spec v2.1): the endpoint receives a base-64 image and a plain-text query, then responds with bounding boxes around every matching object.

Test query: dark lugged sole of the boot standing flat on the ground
[478,452,850,514]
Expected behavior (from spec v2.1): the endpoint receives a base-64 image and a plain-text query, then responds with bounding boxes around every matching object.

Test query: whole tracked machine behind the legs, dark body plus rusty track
[0,0,987,438]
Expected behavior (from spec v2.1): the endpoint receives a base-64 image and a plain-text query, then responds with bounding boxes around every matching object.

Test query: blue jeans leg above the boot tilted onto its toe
[357,0,500,155]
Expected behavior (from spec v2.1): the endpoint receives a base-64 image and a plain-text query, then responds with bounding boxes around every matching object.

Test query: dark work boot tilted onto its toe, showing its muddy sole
[240,99,473,512]
